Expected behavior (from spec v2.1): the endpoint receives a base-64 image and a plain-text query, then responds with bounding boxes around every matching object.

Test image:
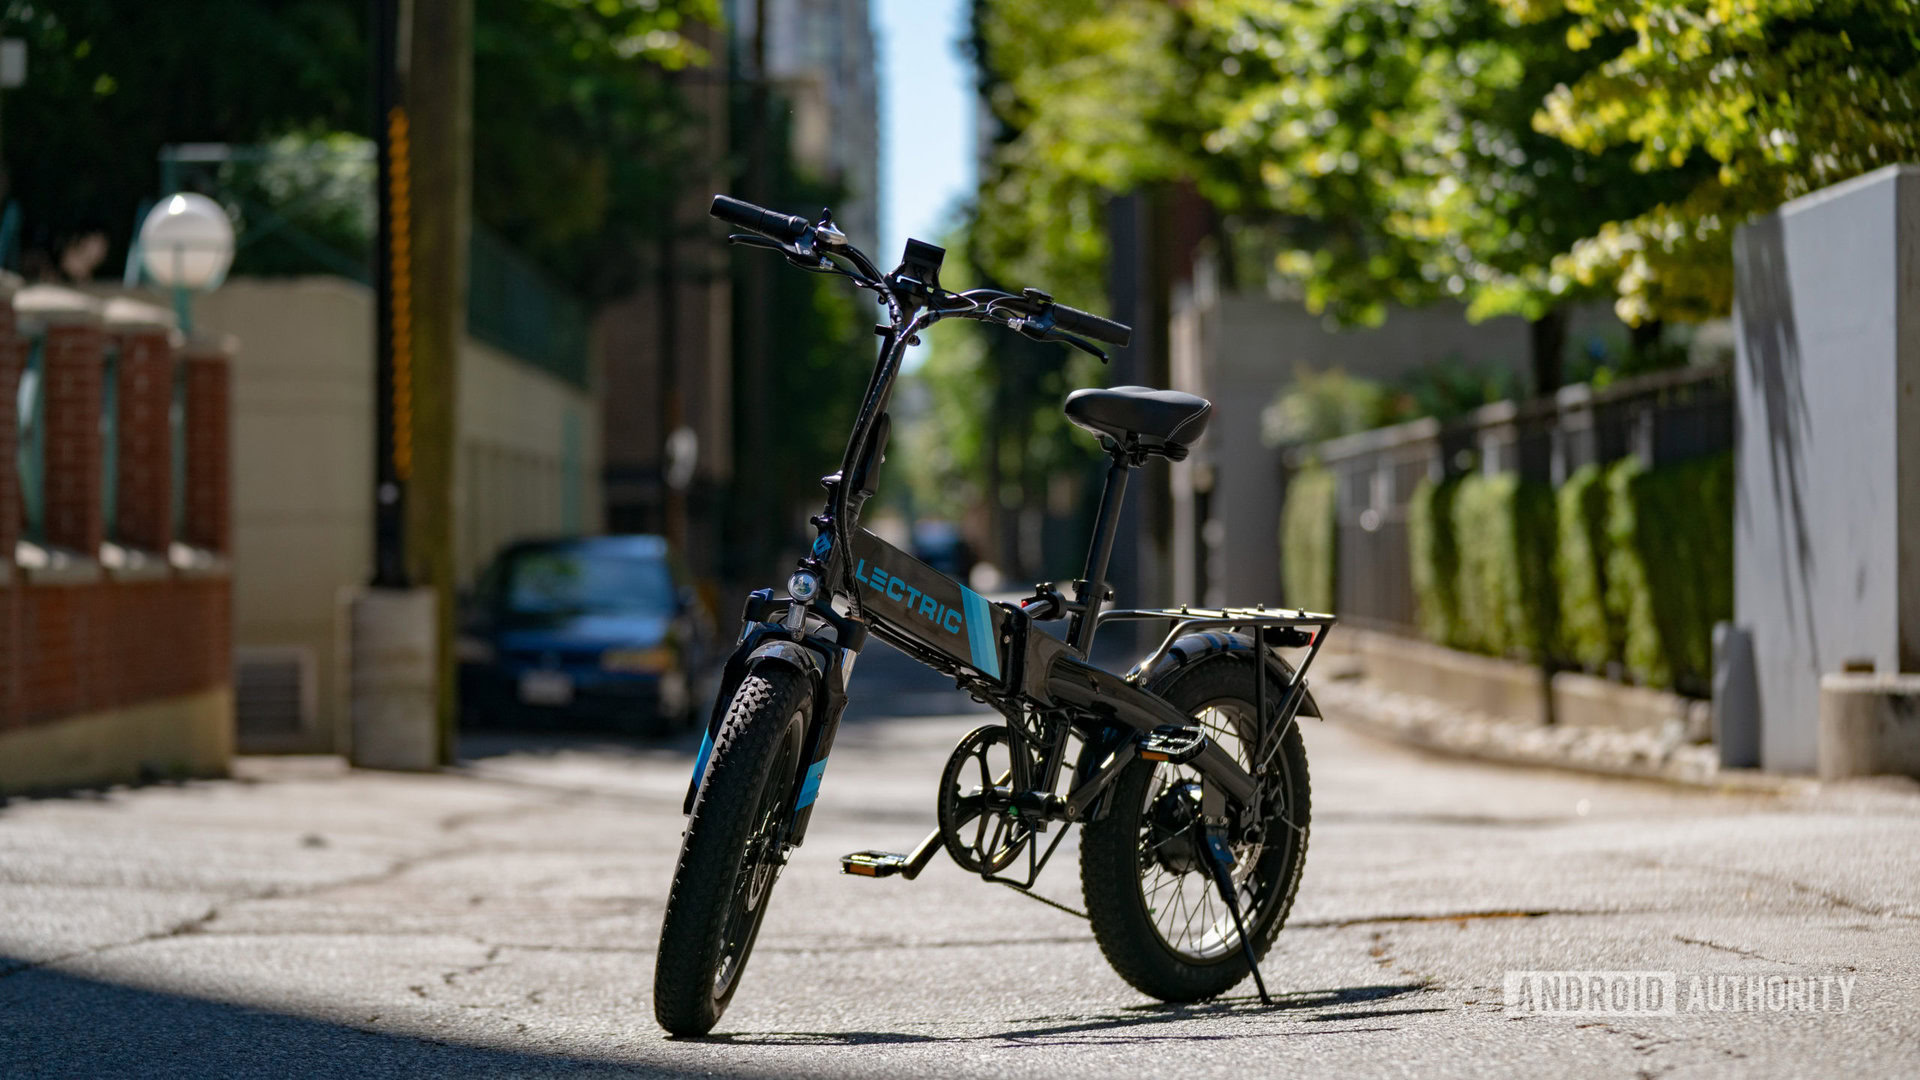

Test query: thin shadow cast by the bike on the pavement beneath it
[687,982,1446,1045]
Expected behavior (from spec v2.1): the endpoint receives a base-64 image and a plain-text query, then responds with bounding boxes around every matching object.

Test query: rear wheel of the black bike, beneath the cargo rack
[1081,653,1311,1001]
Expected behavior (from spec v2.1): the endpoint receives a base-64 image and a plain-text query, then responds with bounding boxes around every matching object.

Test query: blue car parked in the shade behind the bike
[455,536,712,732]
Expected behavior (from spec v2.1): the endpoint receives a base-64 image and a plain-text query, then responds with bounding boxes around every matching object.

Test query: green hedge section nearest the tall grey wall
[1607,454,1734,694]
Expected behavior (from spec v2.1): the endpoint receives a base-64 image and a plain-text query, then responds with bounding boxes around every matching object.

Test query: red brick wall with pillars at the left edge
[0,282,232,736]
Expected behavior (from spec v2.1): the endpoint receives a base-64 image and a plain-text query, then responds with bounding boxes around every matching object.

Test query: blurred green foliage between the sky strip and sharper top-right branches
[983,0,1684,390]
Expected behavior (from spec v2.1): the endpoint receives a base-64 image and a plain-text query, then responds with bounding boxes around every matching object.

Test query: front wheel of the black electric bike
[653,667,812,1036]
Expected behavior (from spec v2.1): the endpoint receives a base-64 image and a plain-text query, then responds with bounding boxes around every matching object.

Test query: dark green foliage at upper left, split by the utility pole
[0,0,720,300]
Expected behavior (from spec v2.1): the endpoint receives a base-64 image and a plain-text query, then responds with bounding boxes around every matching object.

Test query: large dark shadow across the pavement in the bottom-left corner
[0,953,752,1080]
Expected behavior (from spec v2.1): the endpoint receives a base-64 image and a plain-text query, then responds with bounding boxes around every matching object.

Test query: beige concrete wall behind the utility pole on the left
[179,277,601,751]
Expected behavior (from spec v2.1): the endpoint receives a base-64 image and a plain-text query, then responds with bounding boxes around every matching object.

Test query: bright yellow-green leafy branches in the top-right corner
[1500,0,1920,323]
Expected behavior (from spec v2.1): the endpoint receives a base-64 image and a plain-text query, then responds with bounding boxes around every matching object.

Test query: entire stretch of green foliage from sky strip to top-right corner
[981,0,1920,325]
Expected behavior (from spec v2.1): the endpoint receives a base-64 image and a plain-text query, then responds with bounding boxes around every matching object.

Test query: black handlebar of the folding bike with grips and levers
[708,194,1133,349]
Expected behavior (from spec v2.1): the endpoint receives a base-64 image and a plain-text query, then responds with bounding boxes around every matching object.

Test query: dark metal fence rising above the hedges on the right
[1288,363,1734,632]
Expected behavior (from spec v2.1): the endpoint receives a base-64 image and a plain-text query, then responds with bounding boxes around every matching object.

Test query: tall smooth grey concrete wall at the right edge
[1734,165,1920,773]
